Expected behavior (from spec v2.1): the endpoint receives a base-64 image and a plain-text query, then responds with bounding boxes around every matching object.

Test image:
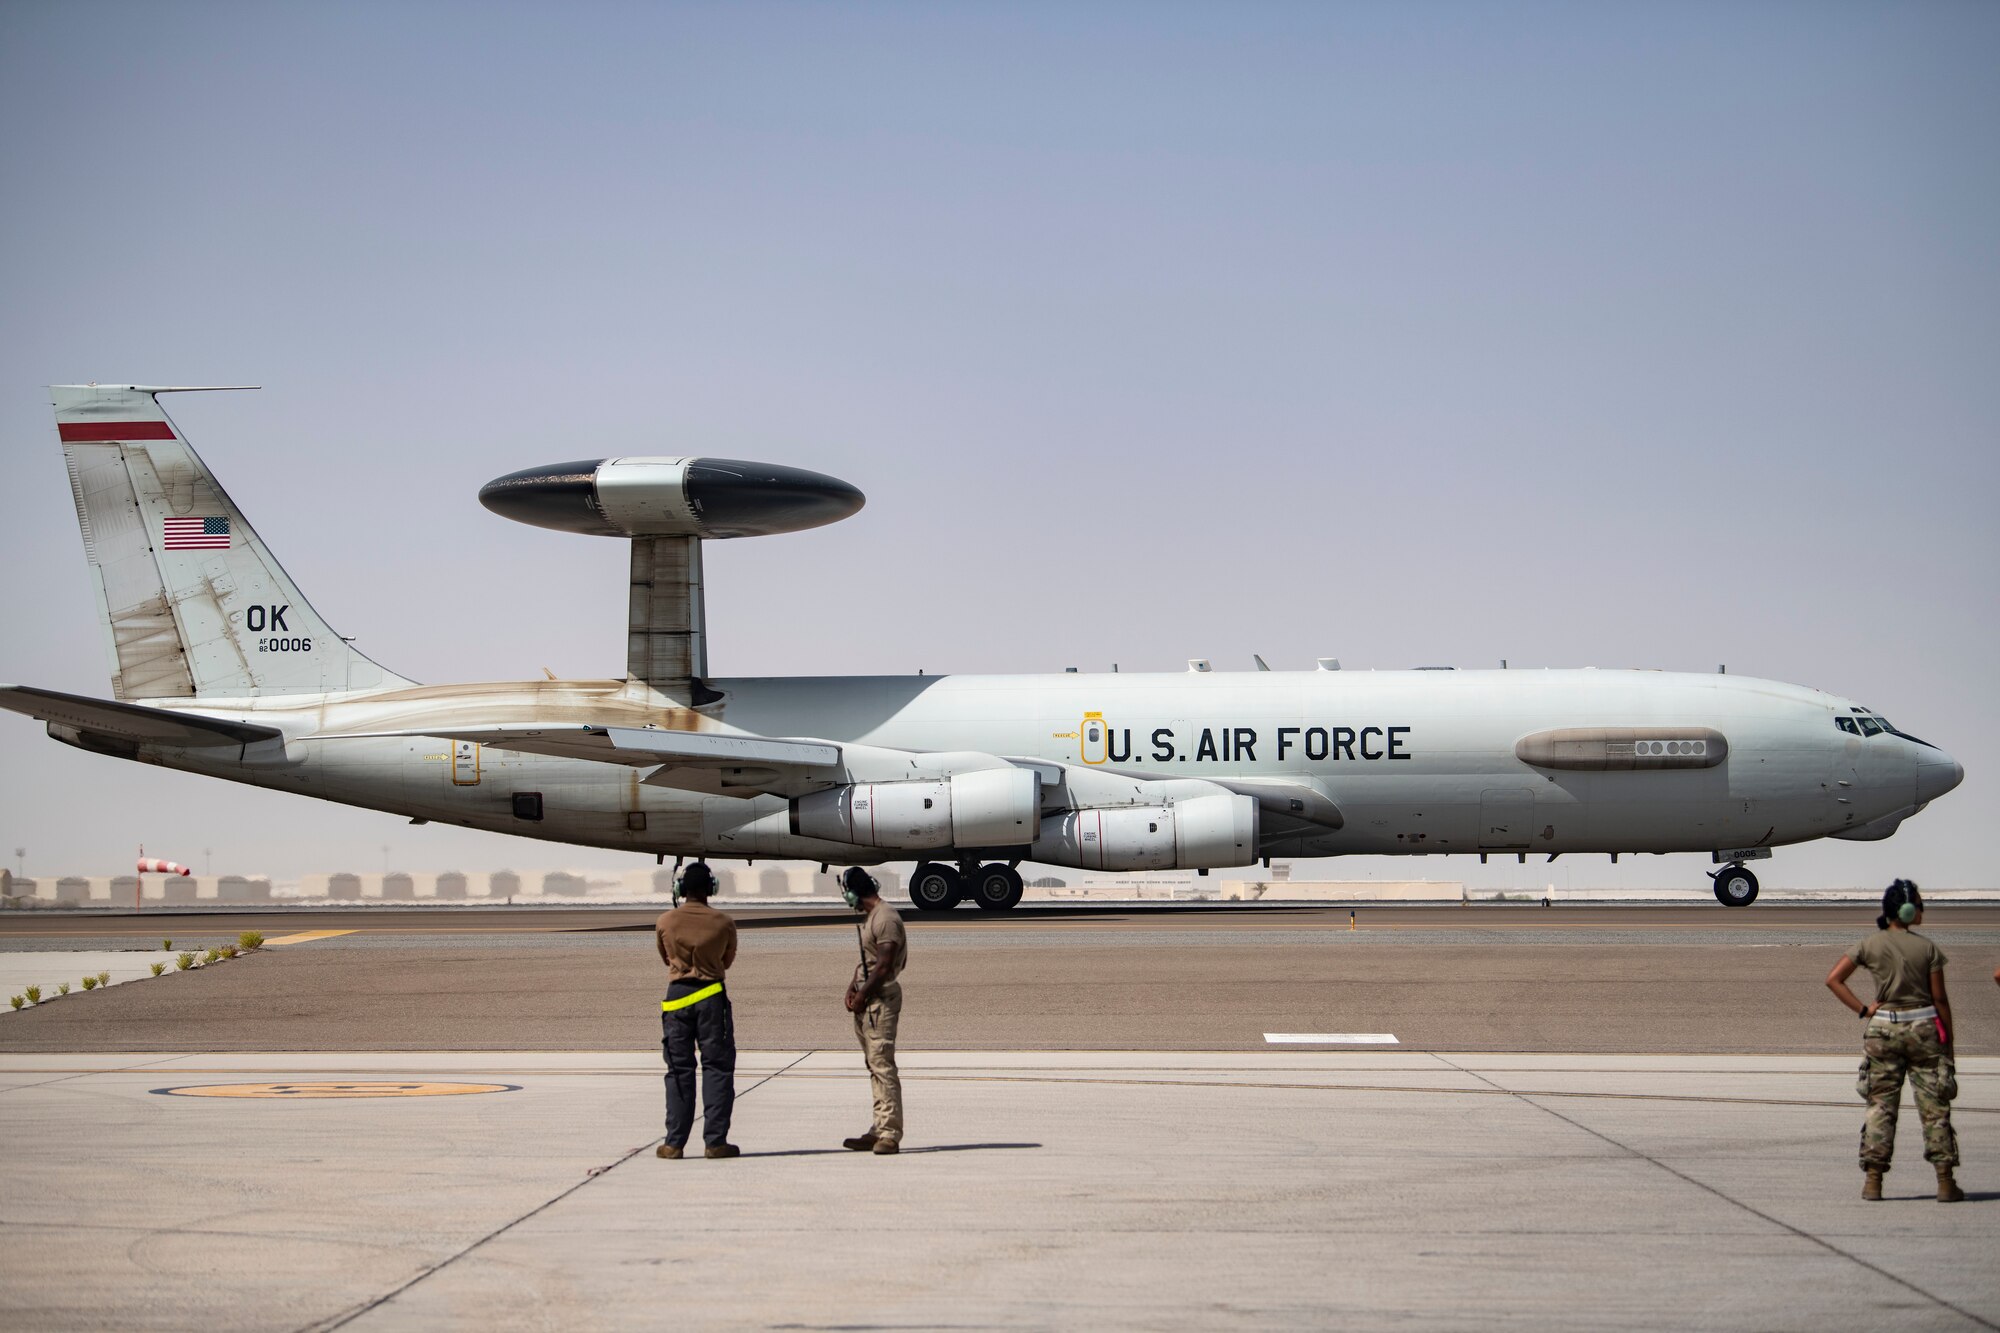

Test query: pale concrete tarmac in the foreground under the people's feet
[0,1051,2000,1331]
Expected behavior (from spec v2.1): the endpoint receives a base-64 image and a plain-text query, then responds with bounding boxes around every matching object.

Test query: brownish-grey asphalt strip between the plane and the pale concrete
[0,905,2000,1055]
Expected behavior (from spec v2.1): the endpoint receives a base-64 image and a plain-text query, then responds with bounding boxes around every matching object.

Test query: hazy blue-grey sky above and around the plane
[0,0,2000,887]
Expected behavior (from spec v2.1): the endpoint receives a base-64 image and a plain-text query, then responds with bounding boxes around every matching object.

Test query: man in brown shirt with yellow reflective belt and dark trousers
[654,861,740,1161]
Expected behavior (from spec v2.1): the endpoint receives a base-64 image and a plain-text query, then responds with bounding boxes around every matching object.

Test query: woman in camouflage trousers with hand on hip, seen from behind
[1826,879,1966,1203]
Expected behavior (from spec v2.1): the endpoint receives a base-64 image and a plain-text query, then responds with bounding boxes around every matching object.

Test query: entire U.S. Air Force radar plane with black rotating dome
[0,384,1964,911]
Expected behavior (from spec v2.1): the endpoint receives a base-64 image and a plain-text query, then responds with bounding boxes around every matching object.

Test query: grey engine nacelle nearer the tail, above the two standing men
[792,769,1042,851]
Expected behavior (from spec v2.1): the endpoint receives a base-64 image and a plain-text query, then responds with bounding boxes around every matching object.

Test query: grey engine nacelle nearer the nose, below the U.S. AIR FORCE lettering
[1032,793,1258,871]
